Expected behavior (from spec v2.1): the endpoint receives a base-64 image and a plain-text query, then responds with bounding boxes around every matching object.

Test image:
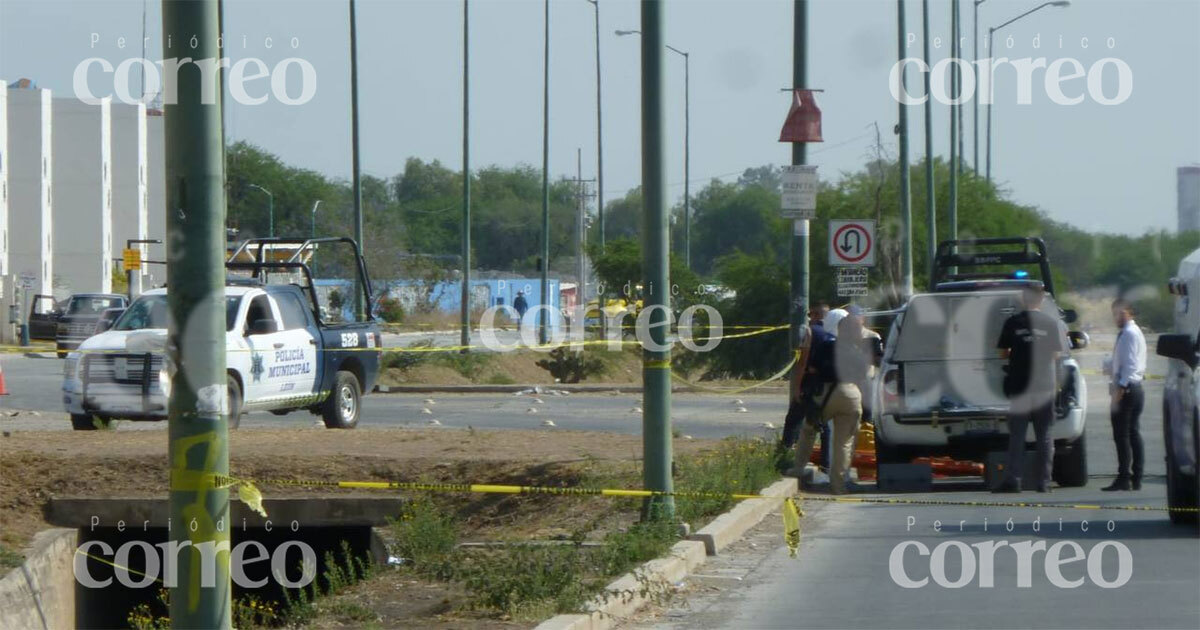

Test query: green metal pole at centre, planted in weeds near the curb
[641,0,674,520]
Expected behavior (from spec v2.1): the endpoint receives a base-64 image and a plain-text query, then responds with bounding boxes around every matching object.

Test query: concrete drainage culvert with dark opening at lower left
[0,497,404,629]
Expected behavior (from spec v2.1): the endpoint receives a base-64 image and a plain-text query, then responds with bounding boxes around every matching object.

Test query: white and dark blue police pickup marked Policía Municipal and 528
[62,239,382,431]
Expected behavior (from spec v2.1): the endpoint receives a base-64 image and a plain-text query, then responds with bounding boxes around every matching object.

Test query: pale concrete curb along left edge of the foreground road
[534,478,798,630]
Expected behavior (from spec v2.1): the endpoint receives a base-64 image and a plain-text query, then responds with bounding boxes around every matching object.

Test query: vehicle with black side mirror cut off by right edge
[1157,250,1200,524]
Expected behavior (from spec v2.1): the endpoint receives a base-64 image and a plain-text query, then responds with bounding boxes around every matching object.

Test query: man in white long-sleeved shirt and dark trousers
[1100,300,1146,492]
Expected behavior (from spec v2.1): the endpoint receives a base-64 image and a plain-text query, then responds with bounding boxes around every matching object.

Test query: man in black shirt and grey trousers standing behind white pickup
[992,282,1067,492]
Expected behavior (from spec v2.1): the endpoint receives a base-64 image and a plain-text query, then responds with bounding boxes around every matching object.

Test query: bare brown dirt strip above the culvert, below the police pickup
[0,428,712,551]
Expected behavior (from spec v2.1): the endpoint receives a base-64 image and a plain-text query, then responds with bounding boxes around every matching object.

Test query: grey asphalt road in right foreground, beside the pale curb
[631,343,1200,630]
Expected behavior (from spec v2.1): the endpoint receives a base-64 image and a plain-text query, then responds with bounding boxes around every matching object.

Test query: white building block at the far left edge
[6,89,54,300]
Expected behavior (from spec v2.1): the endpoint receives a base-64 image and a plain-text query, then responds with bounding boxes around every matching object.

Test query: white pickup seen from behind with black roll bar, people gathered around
[872,239,1087,486]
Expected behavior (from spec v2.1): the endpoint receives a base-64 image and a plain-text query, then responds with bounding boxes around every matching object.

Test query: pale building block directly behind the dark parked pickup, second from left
[52,98,114,293]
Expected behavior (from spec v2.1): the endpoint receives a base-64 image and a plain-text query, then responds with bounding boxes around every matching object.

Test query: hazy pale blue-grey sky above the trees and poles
[0,0,1200,233]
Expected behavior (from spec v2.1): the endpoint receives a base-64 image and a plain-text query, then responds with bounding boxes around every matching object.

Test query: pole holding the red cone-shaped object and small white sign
[791,0,809,348]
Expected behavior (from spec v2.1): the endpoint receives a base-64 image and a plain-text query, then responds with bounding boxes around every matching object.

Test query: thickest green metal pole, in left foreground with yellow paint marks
[162,0,233,629]
